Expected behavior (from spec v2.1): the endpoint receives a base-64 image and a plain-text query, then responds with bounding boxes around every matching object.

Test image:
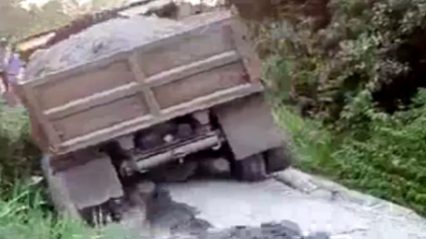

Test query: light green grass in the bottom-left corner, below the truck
[0,184,141,239]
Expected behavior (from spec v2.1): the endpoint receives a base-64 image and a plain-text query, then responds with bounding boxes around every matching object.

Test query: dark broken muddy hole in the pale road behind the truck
[149,188,329,239]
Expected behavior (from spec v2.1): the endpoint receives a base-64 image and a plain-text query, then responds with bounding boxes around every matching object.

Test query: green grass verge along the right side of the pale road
[275,104,426,216]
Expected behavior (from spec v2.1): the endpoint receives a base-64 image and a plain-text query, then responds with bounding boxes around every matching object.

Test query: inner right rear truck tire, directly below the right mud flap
[232,154,266,182]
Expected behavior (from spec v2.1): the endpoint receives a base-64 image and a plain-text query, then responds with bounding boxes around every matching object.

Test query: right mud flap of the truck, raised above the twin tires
[214,94,283,160]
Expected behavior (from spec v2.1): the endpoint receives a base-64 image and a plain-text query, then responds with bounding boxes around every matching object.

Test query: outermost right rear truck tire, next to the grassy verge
[264,146,292,174]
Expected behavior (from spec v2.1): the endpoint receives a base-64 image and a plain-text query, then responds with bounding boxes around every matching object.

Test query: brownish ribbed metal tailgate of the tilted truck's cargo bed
[17,12,263,154]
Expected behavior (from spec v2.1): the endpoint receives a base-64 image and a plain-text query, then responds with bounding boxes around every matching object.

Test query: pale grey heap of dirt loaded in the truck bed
[25,16,185,80]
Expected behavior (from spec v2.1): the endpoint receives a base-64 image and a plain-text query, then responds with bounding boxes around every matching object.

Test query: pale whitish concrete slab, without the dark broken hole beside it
[160,170,426,239]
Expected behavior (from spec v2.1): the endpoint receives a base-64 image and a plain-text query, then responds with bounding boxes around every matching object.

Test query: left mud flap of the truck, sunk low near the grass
[42,152,124,218]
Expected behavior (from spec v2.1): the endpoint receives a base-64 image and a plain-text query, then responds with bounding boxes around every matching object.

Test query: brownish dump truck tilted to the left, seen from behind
[15,11,290,222]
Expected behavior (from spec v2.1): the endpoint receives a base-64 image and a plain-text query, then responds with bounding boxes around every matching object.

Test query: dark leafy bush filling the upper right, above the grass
[256,0,426,124]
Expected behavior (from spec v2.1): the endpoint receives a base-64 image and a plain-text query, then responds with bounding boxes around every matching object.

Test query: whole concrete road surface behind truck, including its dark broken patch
[107,169,426,239]
